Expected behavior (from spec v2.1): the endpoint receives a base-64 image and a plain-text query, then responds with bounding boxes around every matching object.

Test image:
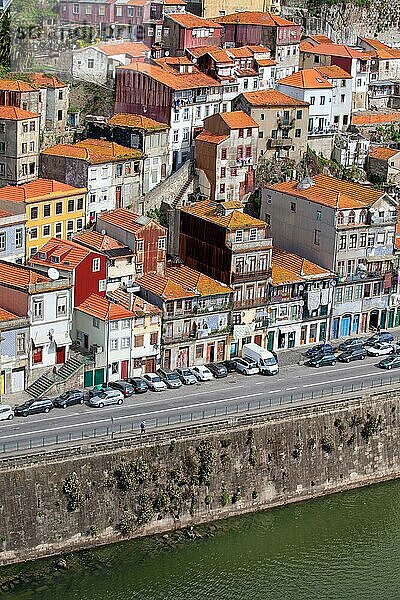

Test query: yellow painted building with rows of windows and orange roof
[0,179,87,260]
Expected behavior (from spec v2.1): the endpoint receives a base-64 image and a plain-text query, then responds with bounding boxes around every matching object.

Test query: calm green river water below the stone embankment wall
[0,481,400,600]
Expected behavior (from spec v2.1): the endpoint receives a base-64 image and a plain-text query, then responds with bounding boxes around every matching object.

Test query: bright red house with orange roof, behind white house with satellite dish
[29,238,107,306]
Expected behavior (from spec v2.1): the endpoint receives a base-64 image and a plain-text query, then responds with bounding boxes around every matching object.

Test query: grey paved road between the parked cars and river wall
[0,358,400,453]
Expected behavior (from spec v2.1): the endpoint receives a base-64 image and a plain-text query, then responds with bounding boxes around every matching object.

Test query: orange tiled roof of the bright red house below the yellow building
[29,238,97,271]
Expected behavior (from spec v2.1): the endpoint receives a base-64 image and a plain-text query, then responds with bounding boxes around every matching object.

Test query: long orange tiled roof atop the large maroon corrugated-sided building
[118,63,221,90]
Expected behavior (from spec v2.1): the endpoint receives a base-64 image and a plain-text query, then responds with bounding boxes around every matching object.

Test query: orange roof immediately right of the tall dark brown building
[272,247,332,286]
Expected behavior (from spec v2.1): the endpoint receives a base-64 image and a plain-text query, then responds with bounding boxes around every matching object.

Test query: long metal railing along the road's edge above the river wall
[0,372,400,455]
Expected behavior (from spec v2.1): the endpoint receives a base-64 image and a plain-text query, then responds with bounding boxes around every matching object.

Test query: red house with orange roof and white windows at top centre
[163,13,222,56]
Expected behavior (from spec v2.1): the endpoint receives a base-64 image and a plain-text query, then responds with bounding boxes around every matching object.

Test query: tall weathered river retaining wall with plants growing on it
[0,390,400,564]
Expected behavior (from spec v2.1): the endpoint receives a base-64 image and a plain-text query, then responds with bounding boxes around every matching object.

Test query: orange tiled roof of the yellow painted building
[0,179,86,202]
